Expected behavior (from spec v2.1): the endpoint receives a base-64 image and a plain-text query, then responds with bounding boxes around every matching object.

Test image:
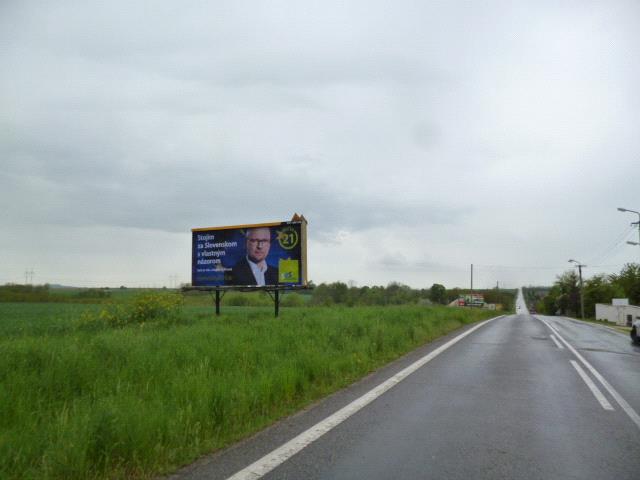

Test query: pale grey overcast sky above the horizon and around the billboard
[0,0,640,287]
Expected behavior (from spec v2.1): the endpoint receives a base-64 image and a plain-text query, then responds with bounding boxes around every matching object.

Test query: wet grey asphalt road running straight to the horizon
[174,290,640,480]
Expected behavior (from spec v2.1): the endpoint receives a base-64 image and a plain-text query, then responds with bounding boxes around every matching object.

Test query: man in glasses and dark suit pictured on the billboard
[231,227,278,286]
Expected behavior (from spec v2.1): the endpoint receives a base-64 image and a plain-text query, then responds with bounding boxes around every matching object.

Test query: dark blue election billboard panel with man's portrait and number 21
[191,215,307,288]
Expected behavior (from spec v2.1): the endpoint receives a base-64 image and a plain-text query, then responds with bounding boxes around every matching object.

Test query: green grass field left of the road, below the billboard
[0,303,495,478]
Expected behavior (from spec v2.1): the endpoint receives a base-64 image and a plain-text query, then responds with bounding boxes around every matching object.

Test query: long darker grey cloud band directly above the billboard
[0,147,464,232]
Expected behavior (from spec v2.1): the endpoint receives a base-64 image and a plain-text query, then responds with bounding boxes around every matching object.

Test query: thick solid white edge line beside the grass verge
[222,315,503,480]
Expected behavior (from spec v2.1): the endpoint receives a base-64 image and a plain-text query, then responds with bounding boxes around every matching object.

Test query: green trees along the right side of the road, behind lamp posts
[523,263,640,318]
